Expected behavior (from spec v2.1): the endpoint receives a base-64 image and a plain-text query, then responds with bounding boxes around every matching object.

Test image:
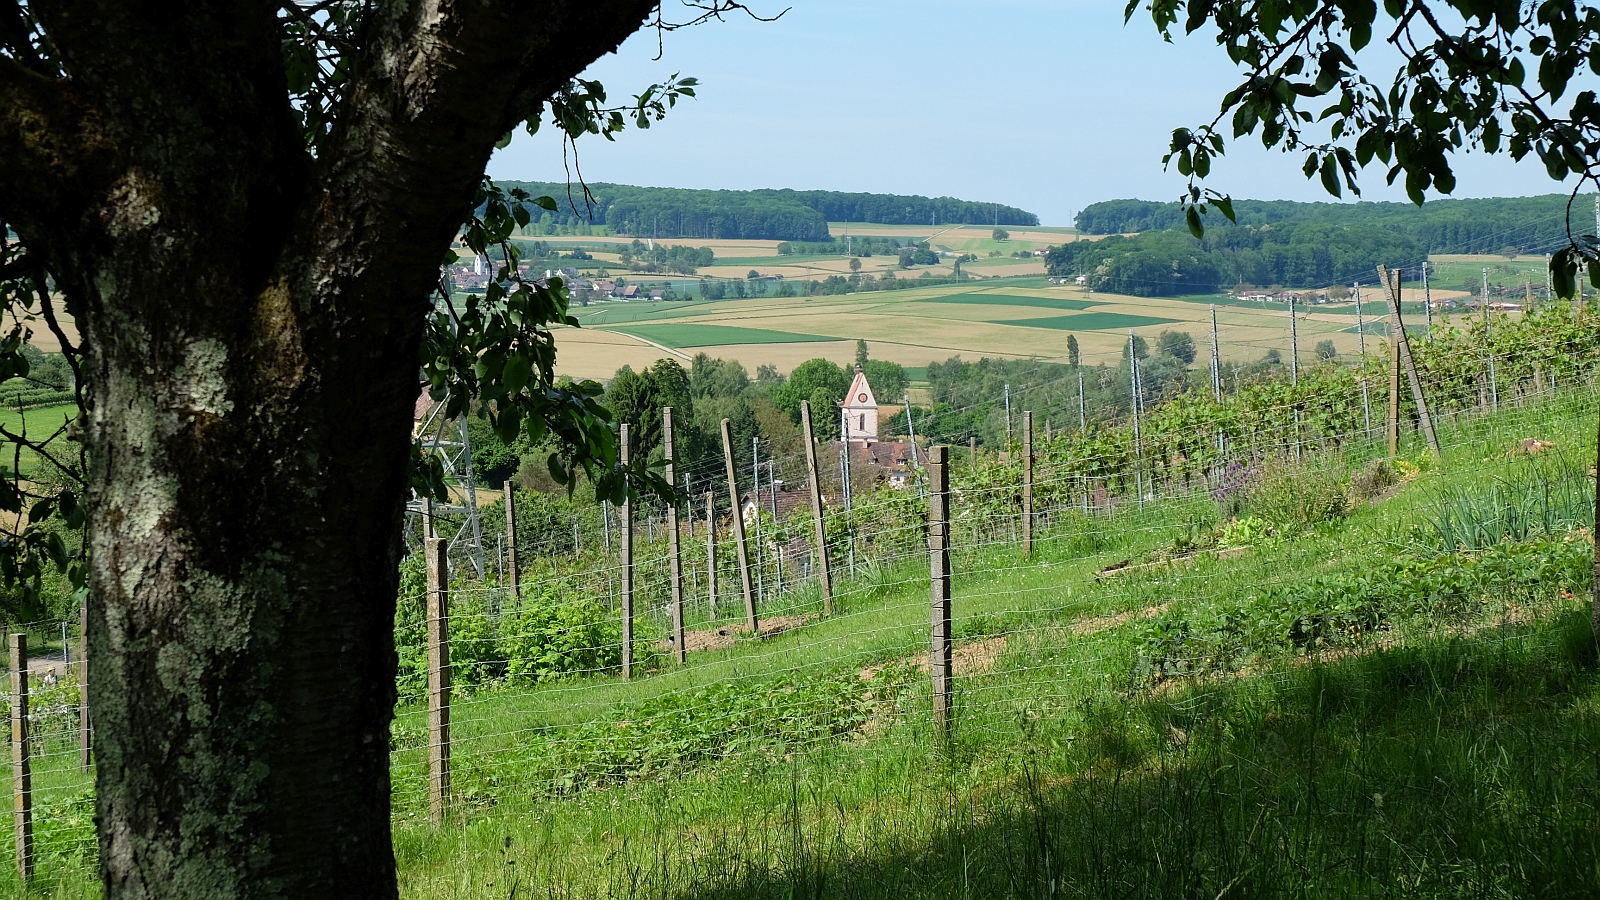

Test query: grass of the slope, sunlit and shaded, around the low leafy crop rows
[384,392,1600,898]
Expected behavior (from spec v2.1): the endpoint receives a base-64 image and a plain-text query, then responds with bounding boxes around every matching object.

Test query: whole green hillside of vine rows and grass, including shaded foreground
[13,303,1600,898]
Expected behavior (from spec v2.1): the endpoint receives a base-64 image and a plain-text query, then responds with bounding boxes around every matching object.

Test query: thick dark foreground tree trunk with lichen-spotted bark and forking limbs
[0,0,653,898]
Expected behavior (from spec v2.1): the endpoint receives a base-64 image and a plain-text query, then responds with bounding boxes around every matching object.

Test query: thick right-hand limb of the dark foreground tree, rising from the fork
[299,0,656,327]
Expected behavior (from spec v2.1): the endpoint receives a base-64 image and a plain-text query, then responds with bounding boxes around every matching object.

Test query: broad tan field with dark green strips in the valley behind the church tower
[557,279,1459,378]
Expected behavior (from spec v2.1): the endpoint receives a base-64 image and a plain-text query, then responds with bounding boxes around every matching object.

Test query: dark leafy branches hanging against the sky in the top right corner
[1125,0,1600,296]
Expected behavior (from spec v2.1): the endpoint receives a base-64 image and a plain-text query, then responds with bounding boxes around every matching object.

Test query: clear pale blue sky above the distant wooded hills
[490,0,1558,224]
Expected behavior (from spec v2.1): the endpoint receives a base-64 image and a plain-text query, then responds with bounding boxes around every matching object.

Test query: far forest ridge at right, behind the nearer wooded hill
[1077,194,1594,253]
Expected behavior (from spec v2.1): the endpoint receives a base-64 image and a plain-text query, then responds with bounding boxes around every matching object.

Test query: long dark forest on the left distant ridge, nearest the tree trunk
[492,181,1038,242]
